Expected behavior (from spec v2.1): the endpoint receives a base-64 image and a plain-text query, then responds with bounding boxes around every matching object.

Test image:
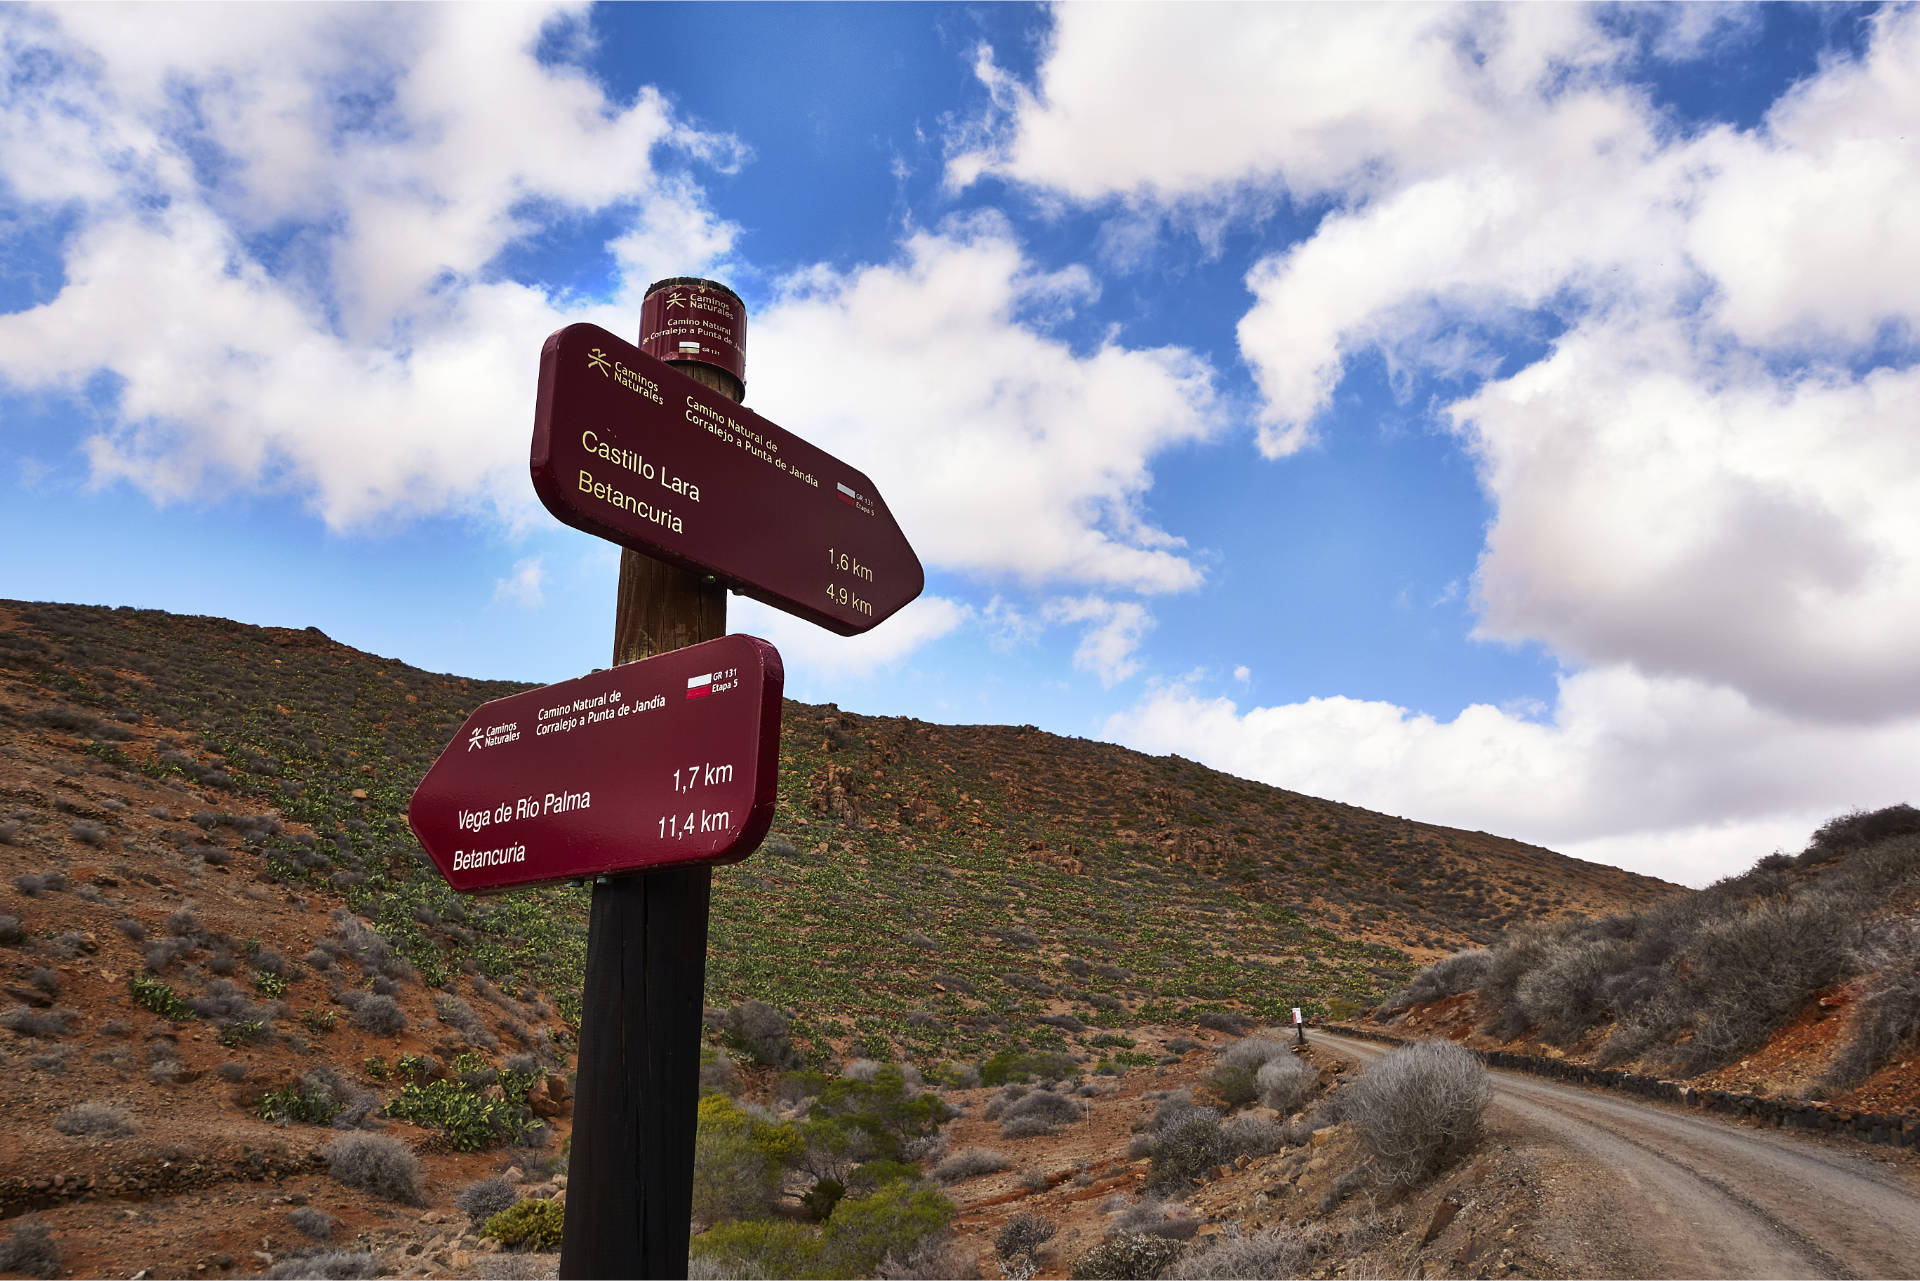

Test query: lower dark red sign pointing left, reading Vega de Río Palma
[407,636,781,893]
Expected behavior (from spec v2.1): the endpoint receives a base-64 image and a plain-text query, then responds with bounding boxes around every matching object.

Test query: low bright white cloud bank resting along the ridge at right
[1106,666,1920,883]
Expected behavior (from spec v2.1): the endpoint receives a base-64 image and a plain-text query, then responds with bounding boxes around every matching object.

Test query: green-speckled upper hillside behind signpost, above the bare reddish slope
[0,603,1674,1058]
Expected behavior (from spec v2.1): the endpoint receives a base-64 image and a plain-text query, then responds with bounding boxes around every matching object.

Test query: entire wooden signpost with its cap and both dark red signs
[407,277,925,1277]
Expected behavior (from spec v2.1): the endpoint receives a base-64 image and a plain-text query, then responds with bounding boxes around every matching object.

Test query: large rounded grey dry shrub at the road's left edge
[1342,1041,1494,1187]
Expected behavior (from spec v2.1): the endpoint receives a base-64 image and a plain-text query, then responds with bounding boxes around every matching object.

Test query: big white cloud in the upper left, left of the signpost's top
[0,6,737,528]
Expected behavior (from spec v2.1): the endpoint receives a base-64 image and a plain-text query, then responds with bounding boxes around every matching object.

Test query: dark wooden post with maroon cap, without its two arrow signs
[561,277,747,1277]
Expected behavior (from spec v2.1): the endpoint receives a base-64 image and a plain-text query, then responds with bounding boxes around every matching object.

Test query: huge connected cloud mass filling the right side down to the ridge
[948,6,1920,880]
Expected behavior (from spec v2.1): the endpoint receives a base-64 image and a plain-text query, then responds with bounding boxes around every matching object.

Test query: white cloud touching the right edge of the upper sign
[749,219,1225,592]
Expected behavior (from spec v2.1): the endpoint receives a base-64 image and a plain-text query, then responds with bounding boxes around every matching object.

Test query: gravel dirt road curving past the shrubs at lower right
[1309,1031,1920,1277]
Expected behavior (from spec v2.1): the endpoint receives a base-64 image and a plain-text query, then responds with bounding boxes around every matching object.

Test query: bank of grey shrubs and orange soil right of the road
[1375,805,1920,1116]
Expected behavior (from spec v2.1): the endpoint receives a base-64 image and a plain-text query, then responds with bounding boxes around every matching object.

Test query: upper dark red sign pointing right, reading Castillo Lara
[532,325,925,636]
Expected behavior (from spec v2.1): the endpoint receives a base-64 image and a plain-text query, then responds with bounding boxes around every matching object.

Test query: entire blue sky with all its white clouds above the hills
[0,4,1920,883]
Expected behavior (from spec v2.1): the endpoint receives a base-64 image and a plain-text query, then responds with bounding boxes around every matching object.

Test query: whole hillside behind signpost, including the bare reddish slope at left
[0,603,1680,1275]
